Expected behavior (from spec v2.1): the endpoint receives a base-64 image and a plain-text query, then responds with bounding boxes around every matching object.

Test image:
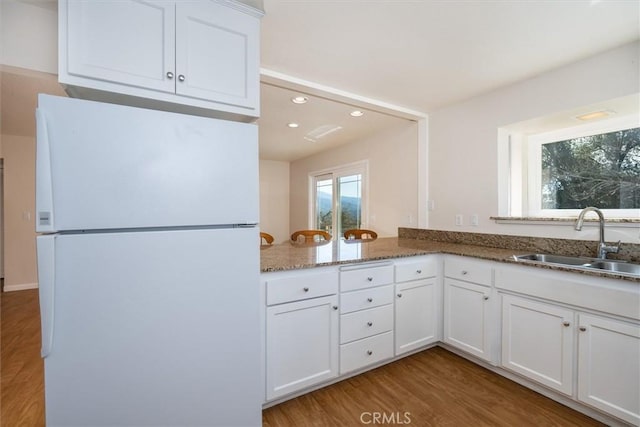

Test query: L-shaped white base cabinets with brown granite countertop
[260,228,640,425]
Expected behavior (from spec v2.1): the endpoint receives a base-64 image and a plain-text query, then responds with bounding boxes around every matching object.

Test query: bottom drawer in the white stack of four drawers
[340,332,393,374]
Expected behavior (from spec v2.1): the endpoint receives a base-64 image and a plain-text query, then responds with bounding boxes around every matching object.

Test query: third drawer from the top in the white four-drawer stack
[340,304,393,344]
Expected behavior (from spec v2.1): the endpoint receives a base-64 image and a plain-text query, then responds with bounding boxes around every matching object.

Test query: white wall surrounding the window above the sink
[429,42,640,243]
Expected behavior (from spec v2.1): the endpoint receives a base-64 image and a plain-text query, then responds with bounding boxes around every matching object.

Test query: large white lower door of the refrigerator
[38,228,263,427]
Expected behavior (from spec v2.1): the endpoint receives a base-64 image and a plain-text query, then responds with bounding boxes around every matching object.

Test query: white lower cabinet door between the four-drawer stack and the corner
[395,279,439,356]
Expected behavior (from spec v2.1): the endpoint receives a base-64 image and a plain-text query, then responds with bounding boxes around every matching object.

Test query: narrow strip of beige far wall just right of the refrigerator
[260,160,290,243]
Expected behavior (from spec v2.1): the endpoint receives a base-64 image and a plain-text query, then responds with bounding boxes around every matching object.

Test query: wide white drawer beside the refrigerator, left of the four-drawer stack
[265,271,338,305]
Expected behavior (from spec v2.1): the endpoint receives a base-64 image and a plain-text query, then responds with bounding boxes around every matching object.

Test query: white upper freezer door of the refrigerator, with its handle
[36,94,259,232]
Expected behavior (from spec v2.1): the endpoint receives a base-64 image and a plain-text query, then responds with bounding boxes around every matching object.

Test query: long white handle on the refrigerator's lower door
[36,235,56,358]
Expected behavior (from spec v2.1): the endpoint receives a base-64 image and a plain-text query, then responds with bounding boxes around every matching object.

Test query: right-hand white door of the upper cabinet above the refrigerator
[176,1,260,110]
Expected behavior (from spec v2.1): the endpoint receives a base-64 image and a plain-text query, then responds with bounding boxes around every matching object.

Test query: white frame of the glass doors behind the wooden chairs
[308,160,369,239]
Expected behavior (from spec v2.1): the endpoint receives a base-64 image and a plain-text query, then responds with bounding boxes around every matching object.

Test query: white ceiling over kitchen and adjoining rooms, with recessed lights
[0,0,640,161]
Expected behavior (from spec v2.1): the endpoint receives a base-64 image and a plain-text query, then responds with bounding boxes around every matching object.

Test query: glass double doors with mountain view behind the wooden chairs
[310,162,367,238]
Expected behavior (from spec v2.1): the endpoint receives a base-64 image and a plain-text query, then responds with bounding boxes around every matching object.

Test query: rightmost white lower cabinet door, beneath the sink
[578,314,640,425]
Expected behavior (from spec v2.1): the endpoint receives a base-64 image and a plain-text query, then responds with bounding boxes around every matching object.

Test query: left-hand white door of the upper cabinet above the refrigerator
[64,0,175,92]
